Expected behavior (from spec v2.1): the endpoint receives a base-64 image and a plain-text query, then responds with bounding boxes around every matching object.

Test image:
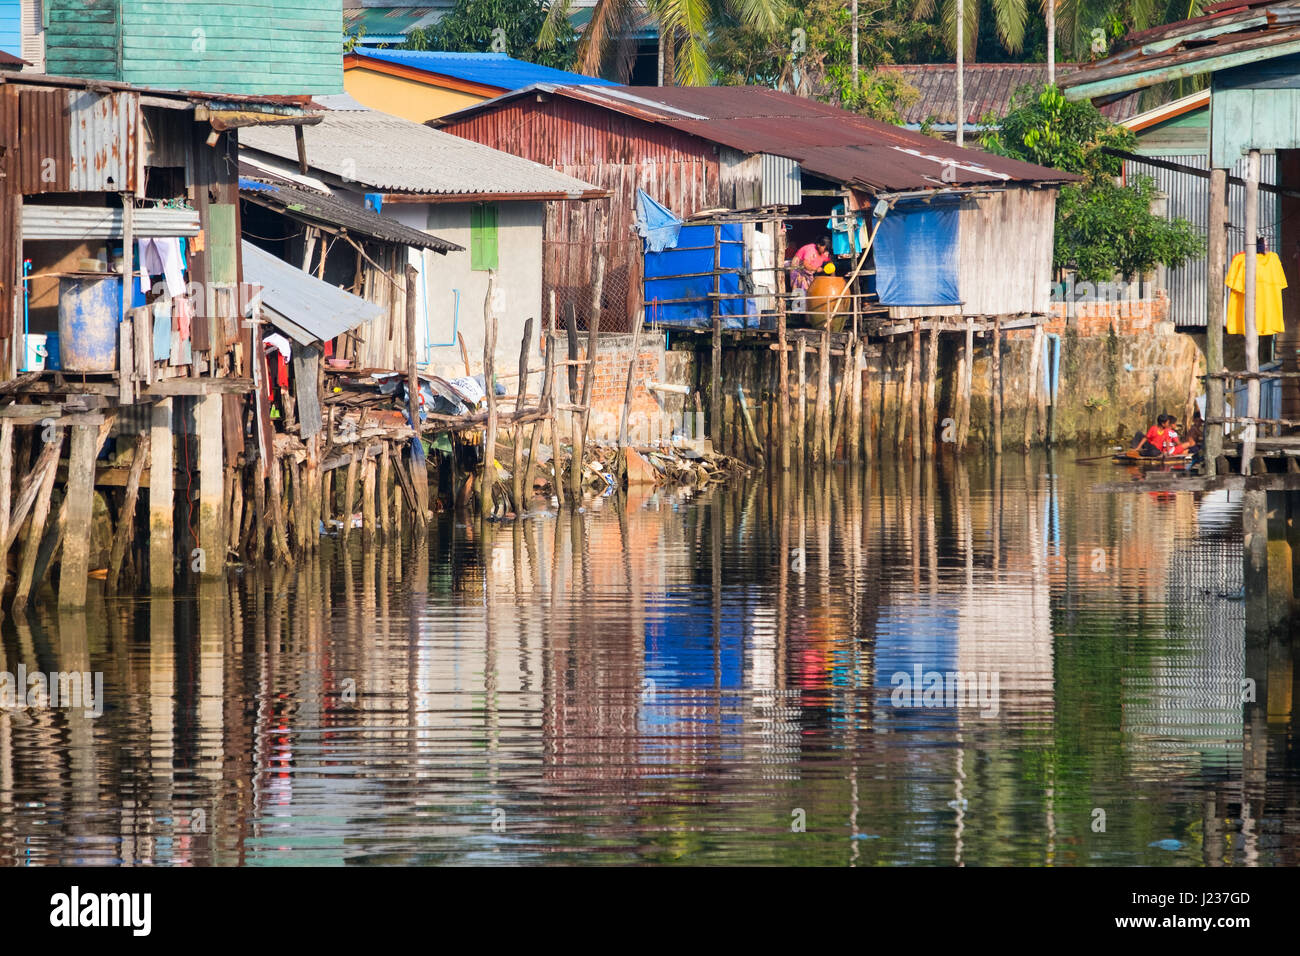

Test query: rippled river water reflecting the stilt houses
[0,455,1300,866]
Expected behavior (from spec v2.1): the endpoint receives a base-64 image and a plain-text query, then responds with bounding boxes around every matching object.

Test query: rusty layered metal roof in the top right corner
[1061,0,1300,98]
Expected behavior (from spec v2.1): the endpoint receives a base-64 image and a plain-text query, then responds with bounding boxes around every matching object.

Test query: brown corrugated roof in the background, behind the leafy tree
[876,62,1138,129]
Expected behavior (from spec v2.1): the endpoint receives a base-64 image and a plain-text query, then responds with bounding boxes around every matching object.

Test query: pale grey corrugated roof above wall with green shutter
[239,109,593,199]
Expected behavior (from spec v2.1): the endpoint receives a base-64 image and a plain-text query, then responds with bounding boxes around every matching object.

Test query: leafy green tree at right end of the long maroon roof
[982,86,1204,282]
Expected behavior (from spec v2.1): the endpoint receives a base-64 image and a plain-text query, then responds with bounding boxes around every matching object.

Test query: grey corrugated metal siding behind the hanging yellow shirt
[1125,153,1279,328]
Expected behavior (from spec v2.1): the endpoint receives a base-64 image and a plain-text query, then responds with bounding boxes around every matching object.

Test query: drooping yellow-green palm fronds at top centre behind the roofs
[538,0,785,86]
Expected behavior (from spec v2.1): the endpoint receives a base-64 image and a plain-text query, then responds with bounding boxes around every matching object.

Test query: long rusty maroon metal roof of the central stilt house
[443,85,1078,193]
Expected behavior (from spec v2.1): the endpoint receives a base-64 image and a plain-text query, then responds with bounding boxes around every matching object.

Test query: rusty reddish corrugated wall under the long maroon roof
[445,98,733,332]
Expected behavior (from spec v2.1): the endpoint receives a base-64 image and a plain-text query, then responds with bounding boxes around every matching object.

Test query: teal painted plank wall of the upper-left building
[46,0,343,94]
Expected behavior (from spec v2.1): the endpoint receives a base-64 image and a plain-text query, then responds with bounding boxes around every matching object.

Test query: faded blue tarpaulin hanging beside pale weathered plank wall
[875,202,962,306]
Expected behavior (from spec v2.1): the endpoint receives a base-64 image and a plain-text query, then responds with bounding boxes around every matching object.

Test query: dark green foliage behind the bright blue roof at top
[402,0,577,70]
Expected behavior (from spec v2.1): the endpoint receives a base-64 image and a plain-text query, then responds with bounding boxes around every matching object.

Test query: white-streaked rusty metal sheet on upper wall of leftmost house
[65,90,140,193]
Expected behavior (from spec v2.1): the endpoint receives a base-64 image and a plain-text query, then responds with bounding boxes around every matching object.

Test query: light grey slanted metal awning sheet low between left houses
[243,239,384,345]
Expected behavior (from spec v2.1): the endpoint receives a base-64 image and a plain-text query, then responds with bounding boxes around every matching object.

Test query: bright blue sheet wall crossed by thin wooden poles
[645,222,757,329]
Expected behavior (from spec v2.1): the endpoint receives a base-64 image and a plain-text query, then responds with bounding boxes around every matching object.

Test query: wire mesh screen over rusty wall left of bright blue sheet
[542,237,641,332]
